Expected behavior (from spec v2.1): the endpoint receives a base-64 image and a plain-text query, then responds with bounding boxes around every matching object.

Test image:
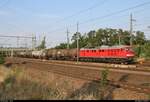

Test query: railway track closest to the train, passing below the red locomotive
[7,58,150,76]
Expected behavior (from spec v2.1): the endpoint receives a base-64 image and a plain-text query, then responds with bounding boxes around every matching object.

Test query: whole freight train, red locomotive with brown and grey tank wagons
[17,45,135,63]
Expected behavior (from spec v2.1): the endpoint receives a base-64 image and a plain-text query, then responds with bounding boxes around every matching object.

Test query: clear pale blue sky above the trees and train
[0,0,150,47]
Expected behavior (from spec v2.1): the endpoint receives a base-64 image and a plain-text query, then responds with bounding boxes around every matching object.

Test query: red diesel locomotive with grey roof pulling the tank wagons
[79,46,135,63]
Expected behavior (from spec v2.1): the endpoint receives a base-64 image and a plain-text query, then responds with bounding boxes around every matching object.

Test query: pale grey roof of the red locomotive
[81,45,131,50]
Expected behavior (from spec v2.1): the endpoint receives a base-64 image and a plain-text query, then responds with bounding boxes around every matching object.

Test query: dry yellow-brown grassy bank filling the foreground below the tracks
[0,67,147,100]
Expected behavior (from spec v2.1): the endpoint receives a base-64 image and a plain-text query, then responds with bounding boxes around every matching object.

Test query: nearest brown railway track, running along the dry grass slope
[27,63,150,94]
